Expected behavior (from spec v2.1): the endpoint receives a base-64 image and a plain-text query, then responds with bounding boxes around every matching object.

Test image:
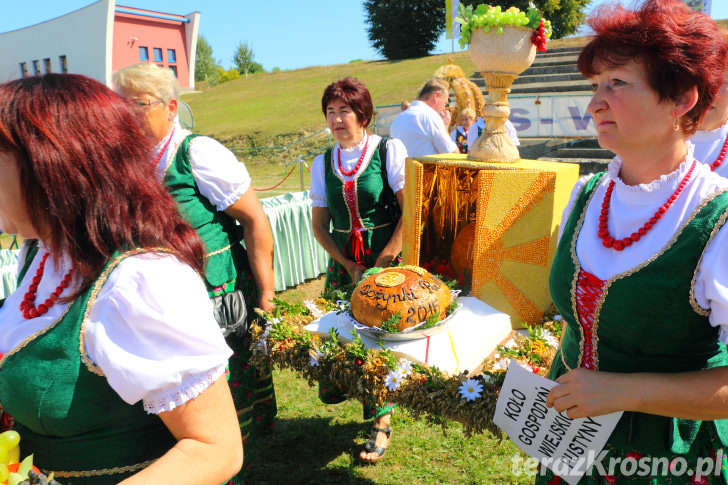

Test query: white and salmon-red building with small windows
[0,0,200,90]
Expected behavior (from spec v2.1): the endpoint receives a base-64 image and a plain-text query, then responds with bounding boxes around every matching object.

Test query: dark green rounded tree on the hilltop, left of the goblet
[364,0,445,59]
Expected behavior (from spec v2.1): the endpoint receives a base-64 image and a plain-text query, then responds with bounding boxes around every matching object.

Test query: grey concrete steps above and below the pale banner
[471,46,614,175]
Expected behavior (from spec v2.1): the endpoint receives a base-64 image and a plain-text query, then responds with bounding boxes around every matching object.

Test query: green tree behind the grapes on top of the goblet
[460,0,592,39]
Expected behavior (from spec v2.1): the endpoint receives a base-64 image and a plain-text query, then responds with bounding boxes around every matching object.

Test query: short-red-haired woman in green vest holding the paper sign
[537,0,728,484]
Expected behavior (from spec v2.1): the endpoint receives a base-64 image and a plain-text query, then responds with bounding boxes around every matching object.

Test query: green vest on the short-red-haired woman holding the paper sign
[549,174,728,456]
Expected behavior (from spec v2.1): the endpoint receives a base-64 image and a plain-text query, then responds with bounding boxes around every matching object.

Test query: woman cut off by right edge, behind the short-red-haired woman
[690,30,728,177]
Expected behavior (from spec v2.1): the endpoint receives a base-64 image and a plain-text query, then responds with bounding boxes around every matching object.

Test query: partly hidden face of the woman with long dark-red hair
[0,152,39,239]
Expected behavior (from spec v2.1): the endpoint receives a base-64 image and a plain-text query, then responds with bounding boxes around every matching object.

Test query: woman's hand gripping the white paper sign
[546,368,629,419]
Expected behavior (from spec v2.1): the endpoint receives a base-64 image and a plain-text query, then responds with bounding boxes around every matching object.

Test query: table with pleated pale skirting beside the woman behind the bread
[260,191,329,291]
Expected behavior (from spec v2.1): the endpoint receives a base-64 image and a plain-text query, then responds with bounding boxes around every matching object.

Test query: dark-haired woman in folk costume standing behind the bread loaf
[310,77,407,462]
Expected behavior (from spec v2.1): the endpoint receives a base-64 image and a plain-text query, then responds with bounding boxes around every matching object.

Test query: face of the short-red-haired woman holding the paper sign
[587,61,675,156]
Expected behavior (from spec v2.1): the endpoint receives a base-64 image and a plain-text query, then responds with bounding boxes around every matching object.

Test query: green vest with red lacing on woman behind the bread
[324,138,396,266]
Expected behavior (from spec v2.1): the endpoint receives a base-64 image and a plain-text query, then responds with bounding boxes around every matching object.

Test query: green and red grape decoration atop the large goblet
[455,3,553,52]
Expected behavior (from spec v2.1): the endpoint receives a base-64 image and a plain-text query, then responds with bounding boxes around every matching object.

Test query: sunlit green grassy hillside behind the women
[183,37,585,146]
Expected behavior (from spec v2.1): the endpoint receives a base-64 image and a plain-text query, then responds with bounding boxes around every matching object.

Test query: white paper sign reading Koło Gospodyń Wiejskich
[493,362,622,485]
